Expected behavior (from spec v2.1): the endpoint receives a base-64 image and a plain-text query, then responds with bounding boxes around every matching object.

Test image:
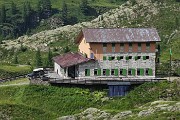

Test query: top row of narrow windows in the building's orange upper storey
[103,42,150,53]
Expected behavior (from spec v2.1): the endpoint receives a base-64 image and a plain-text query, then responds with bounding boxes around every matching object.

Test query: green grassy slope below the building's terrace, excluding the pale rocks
[0,82,180,120]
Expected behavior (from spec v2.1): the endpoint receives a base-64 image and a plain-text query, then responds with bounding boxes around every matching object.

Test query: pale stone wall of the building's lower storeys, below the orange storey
[79,53,156,78]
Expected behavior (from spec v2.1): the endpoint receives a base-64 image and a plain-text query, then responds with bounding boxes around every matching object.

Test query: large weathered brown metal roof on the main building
[79,28,160,43]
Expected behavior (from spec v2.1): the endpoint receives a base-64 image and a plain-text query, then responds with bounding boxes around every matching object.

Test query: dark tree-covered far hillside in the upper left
[0,0,124,40]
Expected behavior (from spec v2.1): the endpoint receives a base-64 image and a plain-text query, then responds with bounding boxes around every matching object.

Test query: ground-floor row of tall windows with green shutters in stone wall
[85,68,153,76]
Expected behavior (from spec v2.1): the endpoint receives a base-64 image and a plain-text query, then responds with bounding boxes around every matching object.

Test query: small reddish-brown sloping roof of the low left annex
[53,52,91,68]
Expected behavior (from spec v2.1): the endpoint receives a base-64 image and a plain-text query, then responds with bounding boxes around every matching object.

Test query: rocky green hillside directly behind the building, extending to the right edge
[3,0,180,62]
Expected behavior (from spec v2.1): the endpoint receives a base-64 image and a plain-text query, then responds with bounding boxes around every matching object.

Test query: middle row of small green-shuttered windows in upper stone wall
[103,56,149,61]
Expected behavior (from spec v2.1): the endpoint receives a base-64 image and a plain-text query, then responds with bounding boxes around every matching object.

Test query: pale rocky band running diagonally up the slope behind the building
[4,0,159,51]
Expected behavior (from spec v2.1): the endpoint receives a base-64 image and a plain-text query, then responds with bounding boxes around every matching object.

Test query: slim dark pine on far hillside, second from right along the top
[62,1,68,24]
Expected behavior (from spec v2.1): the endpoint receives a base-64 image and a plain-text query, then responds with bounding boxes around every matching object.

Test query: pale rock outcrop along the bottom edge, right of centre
[57,101,180,120]
